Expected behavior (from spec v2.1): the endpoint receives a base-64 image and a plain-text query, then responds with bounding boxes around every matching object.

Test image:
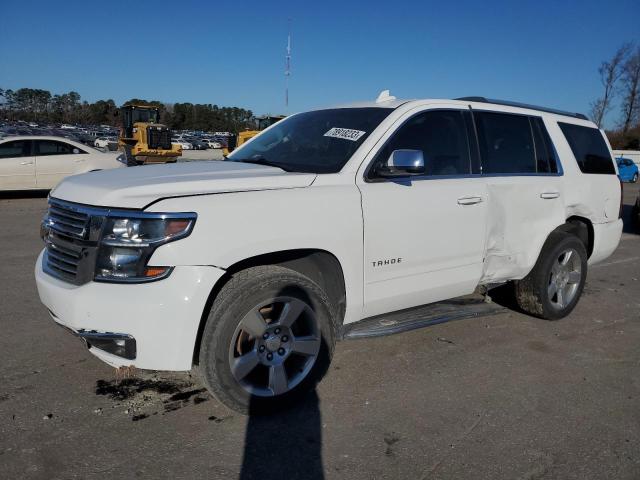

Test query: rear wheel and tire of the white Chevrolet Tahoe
[514,232,587,320]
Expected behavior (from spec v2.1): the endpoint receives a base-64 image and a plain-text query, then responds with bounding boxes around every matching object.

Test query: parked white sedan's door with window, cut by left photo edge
[0,140,36,190]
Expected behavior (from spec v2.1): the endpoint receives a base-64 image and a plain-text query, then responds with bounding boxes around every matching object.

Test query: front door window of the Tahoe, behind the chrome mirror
[374,110,471,176]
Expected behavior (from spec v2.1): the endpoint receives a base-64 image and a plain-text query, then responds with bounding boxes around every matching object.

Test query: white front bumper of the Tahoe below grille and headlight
[35,253,224,371]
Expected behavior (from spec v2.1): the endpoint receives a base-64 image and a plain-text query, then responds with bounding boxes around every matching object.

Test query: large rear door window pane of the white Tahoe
[474,111,538,174]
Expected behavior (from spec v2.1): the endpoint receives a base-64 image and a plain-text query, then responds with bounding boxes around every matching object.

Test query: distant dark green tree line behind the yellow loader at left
[0,88,255,132]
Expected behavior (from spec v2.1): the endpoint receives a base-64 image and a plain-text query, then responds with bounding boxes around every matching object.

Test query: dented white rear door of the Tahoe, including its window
[473,109,565,283]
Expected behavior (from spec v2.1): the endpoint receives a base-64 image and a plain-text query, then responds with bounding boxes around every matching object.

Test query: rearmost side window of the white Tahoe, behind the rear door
[558,122,616,175]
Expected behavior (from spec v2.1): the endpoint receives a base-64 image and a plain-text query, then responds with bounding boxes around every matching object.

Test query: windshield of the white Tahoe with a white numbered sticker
[227,107,393,173]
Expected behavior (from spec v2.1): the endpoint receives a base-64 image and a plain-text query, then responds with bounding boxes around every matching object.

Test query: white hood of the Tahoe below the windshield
[51,160,316,208]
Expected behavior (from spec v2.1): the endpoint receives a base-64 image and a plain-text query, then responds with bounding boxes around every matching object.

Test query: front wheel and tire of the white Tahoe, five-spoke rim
[199,266,335,413]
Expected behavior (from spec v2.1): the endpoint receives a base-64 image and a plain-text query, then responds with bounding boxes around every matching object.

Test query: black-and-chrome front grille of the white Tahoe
[42,198,106,285]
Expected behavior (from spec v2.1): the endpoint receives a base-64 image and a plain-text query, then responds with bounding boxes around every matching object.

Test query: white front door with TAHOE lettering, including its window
[358,109,487,316]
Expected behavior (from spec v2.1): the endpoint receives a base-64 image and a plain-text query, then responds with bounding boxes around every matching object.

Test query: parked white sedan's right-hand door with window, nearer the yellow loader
[35,140,88,189]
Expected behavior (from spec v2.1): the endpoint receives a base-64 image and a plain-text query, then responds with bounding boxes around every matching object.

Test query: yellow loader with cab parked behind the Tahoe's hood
[118,105,182,165]
